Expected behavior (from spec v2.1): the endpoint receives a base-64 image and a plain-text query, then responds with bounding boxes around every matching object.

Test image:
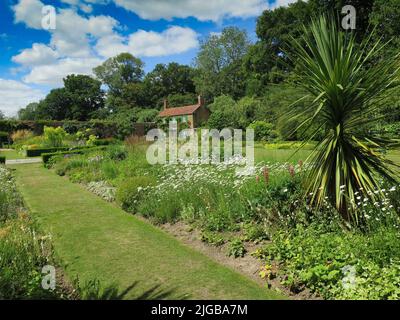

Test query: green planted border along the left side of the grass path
[0,166,58,299]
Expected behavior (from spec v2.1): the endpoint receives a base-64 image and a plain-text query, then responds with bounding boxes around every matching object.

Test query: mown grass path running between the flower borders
[14,164,280,299]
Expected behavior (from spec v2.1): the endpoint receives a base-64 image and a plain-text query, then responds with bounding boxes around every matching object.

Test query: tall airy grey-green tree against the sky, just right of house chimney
[195,27,250,99]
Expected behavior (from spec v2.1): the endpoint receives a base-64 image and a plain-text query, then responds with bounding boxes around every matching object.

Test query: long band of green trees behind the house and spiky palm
[19,0,400,138]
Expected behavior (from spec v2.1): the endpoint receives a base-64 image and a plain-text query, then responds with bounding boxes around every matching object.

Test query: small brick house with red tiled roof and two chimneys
[159,96,210,129]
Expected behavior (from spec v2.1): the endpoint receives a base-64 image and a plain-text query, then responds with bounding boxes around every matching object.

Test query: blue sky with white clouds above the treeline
[0,0,293,116]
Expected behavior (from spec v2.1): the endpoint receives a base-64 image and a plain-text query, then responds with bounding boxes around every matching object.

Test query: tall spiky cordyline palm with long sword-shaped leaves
[288,16,400,222]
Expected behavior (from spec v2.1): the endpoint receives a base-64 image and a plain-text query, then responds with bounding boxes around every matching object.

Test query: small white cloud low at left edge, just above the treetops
[0,78,45,116]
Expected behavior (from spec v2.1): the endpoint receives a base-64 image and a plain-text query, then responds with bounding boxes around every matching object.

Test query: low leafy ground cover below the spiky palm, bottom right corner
[256,224,400,300]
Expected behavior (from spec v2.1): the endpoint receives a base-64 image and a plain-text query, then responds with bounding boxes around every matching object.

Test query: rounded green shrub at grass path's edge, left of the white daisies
[116,176,155,213]
